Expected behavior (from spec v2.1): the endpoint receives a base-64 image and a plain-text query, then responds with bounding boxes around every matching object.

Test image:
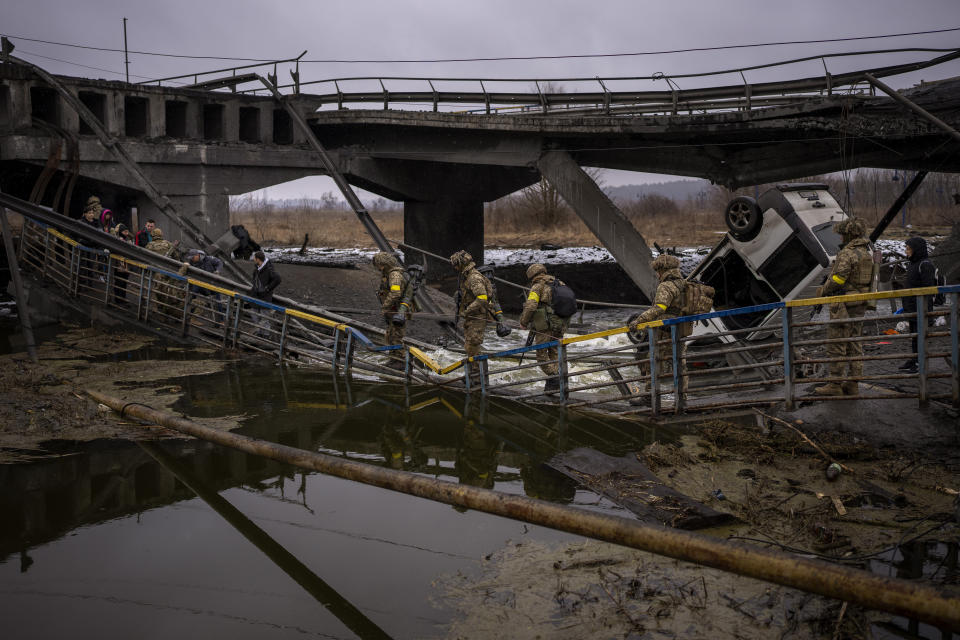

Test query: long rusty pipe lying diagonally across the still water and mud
[87,391,960,631]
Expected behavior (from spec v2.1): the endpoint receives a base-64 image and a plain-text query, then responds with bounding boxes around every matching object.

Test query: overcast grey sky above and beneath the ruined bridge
[0,0,960,197]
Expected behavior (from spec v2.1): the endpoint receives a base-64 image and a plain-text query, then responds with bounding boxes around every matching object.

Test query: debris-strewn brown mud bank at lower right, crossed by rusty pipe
[437,421,960,640]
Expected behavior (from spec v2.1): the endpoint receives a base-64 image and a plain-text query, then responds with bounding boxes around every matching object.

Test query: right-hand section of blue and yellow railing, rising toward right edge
[422,285,960,414]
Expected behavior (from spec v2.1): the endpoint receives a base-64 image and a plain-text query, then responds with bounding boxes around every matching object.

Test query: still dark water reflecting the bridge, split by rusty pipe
[0,363,671,638]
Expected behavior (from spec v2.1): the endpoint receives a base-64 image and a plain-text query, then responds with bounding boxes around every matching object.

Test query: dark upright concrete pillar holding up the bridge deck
[403,198,483,281]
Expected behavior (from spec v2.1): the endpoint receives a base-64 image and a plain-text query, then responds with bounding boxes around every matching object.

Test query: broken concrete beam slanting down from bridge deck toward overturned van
[537,151,658,300]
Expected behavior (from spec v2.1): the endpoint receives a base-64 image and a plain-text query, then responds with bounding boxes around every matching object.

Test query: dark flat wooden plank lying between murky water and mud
[547,448,737,529]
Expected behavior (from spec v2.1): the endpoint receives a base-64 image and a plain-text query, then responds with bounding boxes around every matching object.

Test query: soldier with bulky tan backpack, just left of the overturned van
[628,255,693,404]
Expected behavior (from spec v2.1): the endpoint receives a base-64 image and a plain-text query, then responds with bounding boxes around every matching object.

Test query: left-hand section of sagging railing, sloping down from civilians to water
[19,218,426,380]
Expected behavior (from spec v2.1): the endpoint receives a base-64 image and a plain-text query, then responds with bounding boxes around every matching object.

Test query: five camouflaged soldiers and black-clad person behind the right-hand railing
[373,218,936,404]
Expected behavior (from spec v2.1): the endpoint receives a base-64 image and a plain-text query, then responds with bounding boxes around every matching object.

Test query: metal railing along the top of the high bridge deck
[250,48,960,116]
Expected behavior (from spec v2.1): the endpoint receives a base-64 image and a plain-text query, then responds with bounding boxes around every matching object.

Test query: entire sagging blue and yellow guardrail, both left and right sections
[19,218,960,415]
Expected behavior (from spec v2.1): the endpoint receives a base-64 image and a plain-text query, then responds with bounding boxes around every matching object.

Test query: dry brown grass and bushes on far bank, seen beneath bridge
[230,170,960,247]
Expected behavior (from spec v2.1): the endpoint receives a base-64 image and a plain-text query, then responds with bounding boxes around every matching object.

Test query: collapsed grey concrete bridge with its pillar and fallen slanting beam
[0,51,960,293]
